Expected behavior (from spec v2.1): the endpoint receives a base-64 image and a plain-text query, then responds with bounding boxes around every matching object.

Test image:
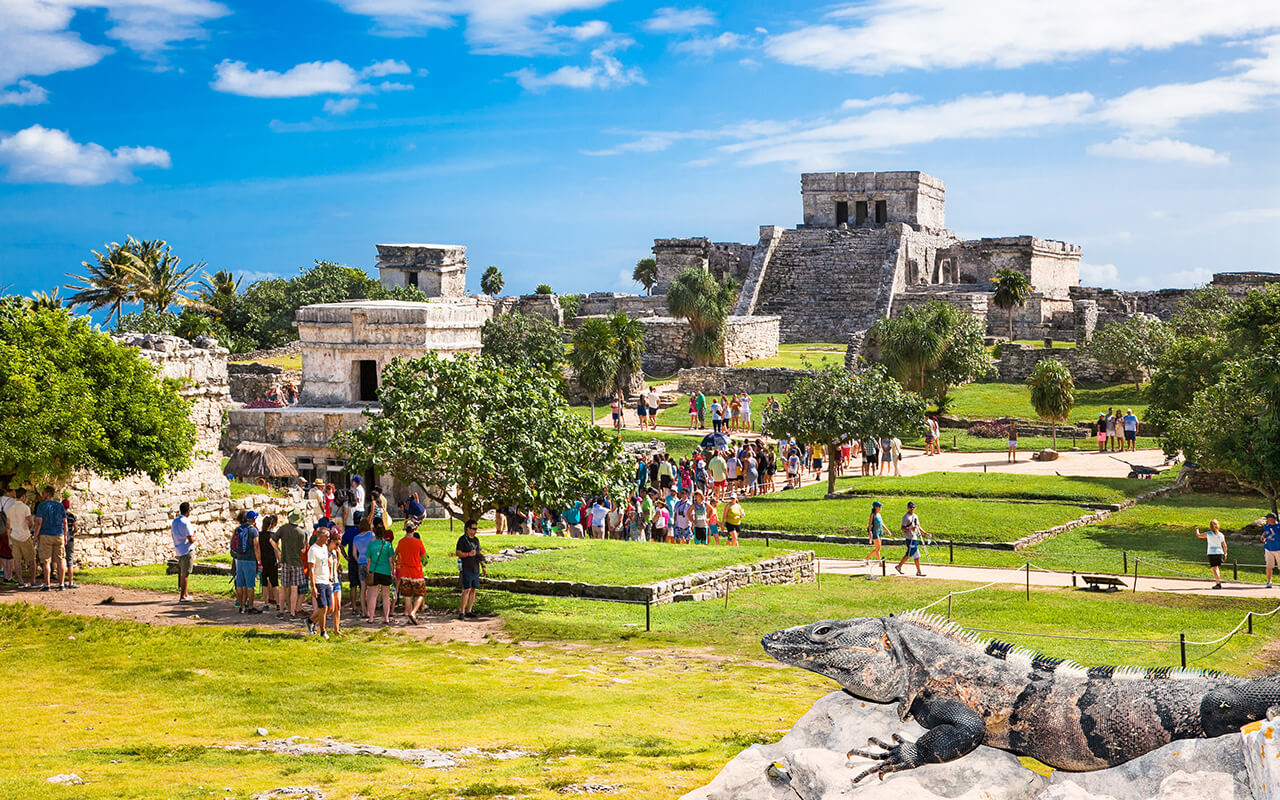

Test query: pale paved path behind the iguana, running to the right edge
[818,548,1280,604]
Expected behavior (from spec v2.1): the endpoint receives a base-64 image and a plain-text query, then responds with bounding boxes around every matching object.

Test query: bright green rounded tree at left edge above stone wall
[0,298,196,483]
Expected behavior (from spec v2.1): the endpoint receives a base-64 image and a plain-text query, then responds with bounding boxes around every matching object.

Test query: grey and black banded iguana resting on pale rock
[760,612,1280,783]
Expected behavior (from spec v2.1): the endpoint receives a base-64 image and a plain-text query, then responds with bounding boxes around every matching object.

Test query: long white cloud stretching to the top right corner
[765,0,1280,74]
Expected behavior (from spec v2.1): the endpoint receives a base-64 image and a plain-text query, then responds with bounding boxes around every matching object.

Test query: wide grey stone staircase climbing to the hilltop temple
[754,228,901,342]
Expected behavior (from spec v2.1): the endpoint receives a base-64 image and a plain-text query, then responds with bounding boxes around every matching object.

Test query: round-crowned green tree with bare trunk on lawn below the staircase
[769,365,924,494]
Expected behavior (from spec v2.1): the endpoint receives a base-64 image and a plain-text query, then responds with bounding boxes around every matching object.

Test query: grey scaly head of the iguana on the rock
[760,617,906,703]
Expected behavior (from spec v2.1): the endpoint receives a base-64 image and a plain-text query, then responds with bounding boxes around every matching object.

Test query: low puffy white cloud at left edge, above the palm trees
[0,125,169,186]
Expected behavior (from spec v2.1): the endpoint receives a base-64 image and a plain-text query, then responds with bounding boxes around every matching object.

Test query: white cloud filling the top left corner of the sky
[0,0,230,88]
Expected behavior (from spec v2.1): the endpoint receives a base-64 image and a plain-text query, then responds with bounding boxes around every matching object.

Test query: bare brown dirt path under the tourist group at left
[0,584,506,644]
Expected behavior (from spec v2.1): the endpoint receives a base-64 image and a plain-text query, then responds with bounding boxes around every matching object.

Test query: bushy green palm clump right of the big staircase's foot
[870,300,993,412]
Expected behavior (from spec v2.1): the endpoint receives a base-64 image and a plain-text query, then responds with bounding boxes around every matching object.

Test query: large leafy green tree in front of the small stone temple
[337,353,632,520]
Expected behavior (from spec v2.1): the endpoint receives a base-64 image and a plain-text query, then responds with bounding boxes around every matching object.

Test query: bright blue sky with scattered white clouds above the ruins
[0,0,1280,300]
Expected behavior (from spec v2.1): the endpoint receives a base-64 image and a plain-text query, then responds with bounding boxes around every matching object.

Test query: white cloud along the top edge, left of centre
[332,0,609,55]
